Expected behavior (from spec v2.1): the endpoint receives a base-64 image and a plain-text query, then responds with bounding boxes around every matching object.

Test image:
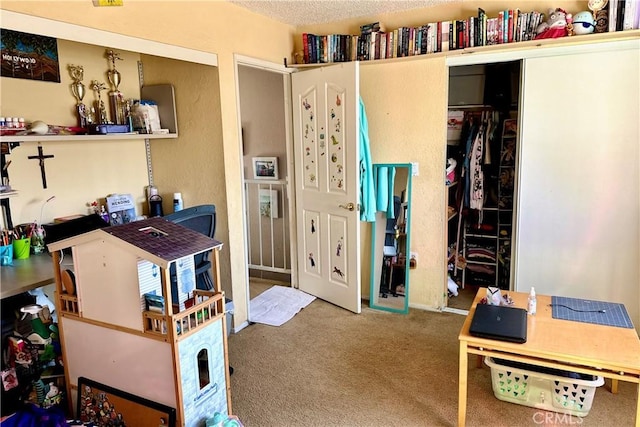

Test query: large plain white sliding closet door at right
[515,40,640,328]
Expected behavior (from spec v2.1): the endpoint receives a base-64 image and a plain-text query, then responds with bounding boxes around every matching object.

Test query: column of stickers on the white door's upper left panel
[299,88,318,188]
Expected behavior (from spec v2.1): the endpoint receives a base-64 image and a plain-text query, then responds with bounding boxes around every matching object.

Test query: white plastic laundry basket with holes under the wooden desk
[484,357,604,417]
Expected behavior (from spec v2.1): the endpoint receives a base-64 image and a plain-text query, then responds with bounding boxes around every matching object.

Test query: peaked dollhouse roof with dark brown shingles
[48,217,222,268]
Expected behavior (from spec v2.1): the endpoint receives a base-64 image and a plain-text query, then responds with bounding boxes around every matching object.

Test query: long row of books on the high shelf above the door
[302,6,640,64]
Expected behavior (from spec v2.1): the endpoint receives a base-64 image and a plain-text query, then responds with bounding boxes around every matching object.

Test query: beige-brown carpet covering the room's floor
[229,284,638,427]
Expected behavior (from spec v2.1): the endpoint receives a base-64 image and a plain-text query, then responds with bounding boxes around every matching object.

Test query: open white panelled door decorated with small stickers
[292,61,361,313]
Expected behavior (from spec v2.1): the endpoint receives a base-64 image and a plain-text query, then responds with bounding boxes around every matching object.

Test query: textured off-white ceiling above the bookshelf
[230,0,455,26]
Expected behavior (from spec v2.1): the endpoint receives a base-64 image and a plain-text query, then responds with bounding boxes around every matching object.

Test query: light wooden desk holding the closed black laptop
[458,288,640,427]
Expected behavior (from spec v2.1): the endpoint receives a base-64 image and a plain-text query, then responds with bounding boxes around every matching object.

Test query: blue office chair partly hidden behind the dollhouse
[164,205,216,301]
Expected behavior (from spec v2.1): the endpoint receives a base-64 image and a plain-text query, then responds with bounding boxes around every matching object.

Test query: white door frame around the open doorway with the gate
[233,53,298,319]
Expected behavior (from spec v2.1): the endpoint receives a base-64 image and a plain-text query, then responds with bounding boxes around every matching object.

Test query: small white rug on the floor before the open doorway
[249,286,316,326]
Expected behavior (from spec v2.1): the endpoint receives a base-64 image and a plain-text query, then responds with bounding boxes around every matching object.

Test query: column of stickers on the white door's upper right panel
[327,85,345,194]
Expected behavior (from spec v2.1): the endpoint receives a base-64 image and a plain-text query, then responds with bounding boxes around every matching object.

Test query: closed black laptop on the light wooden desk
[469,304,527,343]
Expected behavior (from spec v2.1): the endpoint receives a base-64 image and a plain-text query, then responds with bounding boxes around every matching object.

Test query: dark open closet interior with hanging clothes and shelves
[445,61,520,309]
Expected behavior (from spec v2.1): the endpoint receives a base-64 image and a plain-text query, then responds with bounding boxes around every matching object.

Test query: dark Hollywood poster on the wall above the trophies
[0,28,60,83]
